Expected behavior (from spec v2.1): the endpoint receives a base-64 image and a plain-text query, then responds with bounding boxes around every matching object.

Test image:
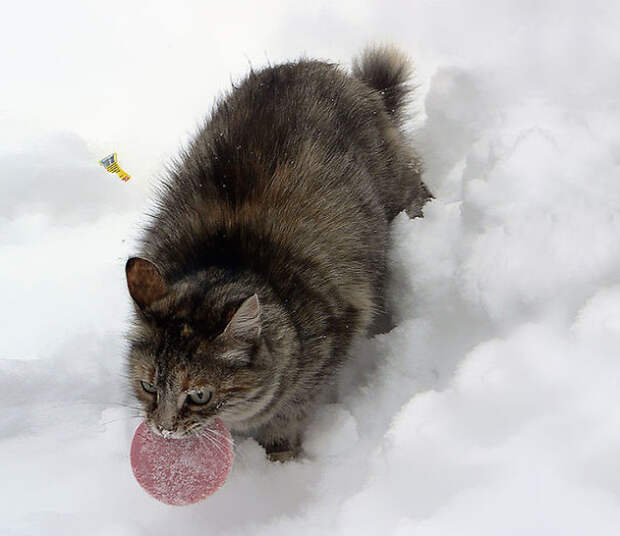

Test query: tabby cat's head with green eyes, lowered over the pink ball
[126,258,277,437]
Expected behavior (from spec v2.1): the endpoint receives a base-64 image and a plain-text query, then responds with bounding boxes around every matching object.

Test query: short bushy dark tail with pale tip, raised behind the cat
[352,46,413,120]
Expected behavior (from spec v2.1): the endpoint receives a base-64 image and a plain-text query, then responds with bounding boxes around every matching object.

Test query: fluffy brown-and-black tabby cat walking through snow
[126,47,431,459]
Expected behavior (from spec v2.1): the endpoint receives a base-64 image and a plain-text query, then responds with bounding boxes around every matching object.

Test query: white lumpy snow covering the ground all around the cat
[0,0,620,536]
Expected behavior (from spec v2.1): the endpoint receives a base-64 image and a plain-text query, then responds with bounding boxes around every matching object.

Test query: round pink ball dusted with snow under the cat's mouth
[130,419,233,506]
